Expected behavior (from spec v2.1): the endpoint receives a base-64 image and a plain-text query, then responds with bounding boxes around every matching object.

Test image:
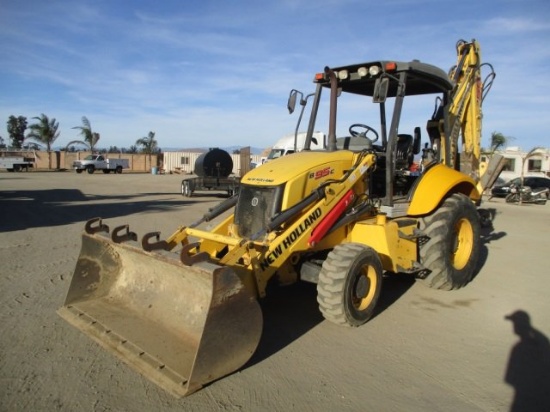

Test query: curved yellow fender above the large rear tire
[408,164,481,216]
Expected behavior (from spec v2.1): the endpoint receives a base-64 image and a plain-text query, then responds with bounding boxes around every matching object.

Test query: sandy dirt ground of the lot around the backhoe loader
[0,172,550,412]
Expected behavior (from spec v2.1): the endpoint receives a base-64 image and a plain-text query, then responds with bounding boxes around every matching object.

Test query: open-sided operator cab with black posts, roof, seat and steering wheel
[308,60,452,208]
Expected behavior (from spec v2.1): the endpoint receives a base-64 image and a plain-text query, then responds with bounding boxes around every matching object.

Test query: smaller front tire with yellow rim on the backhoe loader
[317,243,383,327]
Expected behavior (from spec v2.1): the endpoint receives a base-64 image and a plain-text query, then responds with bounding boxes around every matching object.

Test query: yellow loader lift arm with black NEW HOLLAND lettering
[169,152,376,297]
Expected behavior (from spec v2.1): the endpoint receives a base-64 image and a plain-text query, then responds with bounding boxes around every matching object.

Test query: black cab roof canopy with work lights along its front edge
[322,60,453,97]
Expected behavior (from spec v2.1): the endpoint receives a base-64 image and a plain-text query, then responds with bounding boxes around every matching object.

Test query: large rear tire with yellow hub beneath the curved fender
[419,193,481,290]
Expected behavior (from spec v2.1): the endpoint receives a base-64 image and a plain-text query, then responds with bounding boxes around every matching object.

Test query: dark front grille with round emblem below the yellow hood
[235,185,282,238]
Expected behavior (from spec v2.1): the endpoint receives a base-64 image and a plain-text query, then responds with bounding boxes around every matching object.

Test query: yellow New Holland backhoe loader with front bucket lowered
[58,40,498,396]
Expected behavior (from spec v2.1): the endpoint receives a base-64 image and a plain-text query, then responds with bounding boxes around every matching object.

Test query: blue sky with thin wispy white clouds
[0,0,550,150]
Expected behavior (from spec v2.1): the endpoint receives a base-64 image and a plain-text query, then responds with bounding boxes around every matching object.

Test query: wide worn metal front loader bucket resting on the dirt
[58,233,262,397]
